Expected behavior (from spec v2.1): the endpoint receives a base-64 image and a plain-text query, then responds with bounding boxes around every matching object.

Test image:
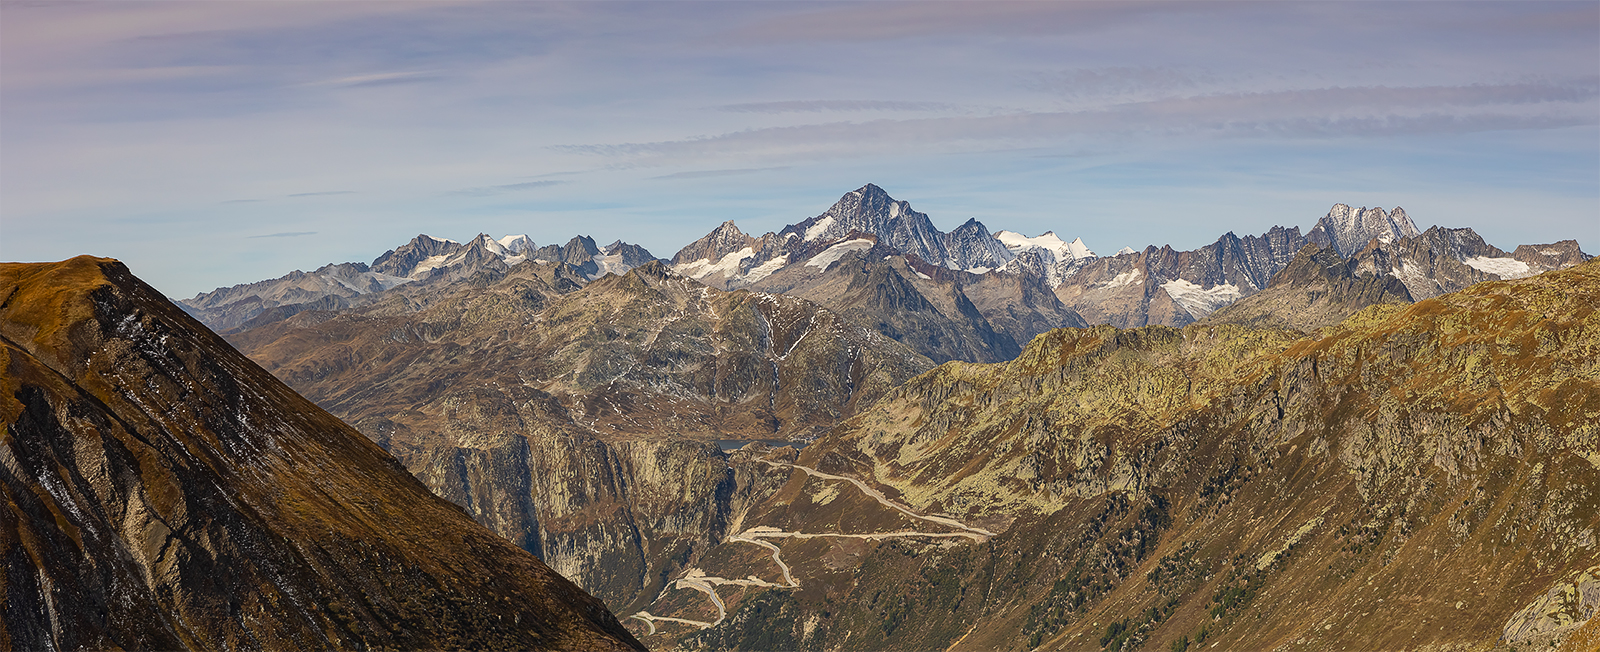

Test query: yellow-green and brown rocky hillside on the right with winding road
[630,257,1600,650]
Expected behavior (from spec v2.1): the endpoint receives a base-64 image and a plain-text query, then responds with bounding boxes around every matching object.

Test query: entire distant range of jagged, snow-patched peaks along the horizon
[179,184,1589,363]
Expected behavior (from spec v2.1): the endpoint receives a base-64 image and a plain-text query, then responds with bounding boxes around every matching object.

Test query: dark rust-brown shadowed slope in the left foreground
[0,257,640,650]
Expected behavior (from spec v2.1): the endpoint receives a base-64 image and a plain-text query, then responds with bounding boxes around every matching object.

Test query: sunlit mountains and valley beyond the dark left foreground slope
[18,185,1600,650]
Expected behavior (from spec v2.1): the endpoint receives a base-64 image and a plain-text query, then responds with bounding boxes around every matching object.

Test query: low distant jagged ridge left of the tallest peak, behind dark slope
[178,233,656,331]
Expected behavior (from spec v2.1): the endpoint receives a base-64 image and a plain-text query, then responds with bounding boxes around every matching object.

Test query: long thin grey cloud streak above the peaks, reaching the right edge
[557,78,1600,165]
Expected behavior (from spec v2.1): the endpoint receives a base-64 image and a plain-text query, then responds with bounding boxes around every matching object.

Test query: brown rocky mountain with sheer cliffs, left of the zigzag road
[219,262,933,609]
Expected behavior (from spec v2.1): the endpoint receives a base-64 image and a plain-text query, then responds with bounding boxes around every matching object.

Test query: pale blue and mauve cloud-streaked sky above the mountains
[0,0,1600,297]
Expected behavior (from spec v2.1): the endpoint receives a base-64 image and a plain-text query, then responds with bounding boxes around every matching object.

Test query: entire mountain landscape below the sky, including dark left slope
[0,184,1600,652]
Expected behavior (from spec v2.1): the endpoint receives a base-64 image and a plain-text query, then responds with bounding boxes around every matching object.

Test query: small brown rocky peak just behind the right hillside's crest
[1202,245,1411,332]
